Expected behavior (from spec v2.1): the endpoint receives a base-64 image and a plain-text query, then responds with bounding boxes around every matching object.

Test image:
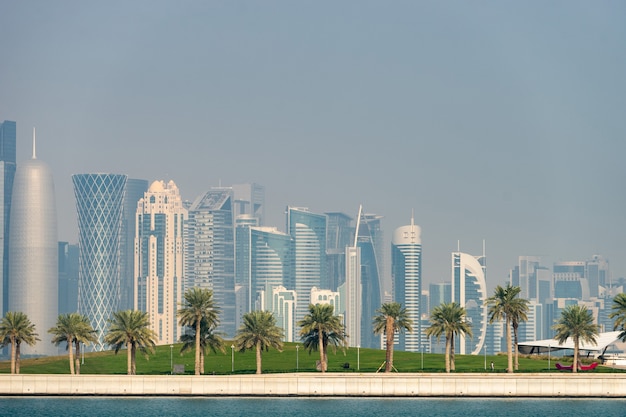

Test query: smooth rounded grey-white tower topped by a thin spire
[9,129,58,355]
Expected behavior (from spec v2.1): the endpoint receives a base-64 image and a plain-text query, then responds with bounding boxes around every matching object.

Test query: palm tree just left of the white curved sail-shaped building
[426,302,472,372]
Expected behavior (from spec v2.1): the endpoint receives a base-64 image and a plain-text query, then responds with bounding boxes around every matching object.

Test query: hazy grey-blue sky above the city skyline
[0,0,626,288]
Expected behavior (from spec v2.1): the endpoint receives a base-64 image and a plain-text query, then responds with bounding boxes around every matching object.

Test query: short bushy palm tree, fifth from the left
[235,311,285,374]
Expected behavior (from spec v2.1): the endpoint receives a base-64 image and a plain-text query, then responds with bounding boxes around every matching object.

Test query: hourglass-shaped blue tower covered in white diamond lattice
[72,174,127,350]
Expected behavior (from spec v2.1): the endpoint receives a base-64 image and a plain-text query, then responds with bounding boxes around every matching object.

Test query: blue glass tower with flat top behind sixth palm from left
[285,207,328,323]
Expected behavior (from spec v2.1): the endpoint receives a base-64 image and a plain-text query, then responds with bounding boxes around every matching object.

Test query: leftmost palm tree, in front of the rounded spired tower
[0,311,41,374]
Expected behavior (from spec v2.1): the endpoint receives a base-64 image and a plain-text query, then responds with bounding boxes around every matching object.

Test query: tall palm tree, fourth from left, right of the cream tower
[178,287,219,375]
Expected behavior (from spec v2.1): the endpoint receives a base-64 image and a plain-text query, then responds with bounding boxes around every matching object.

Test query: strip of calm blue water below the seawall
[0,397,626,417]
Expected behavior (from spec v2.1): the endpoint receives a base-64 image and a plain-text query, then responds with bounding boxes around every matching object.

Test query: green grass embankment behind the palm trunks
[0,342,623,375]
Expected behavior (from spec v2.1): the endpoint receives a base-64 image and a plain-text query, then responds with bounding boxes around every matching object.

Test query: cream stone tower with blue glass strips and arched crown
[134,181,187,345]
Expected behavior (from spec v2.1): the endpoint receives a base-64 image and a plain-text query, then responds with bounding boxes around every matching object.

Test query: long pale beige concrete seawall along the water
[0,373,626,397]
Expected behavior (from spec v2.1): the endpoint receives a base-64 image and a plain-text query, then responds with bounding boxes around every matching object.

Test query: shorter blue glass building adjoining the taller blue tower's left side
[235,225,292,313]
